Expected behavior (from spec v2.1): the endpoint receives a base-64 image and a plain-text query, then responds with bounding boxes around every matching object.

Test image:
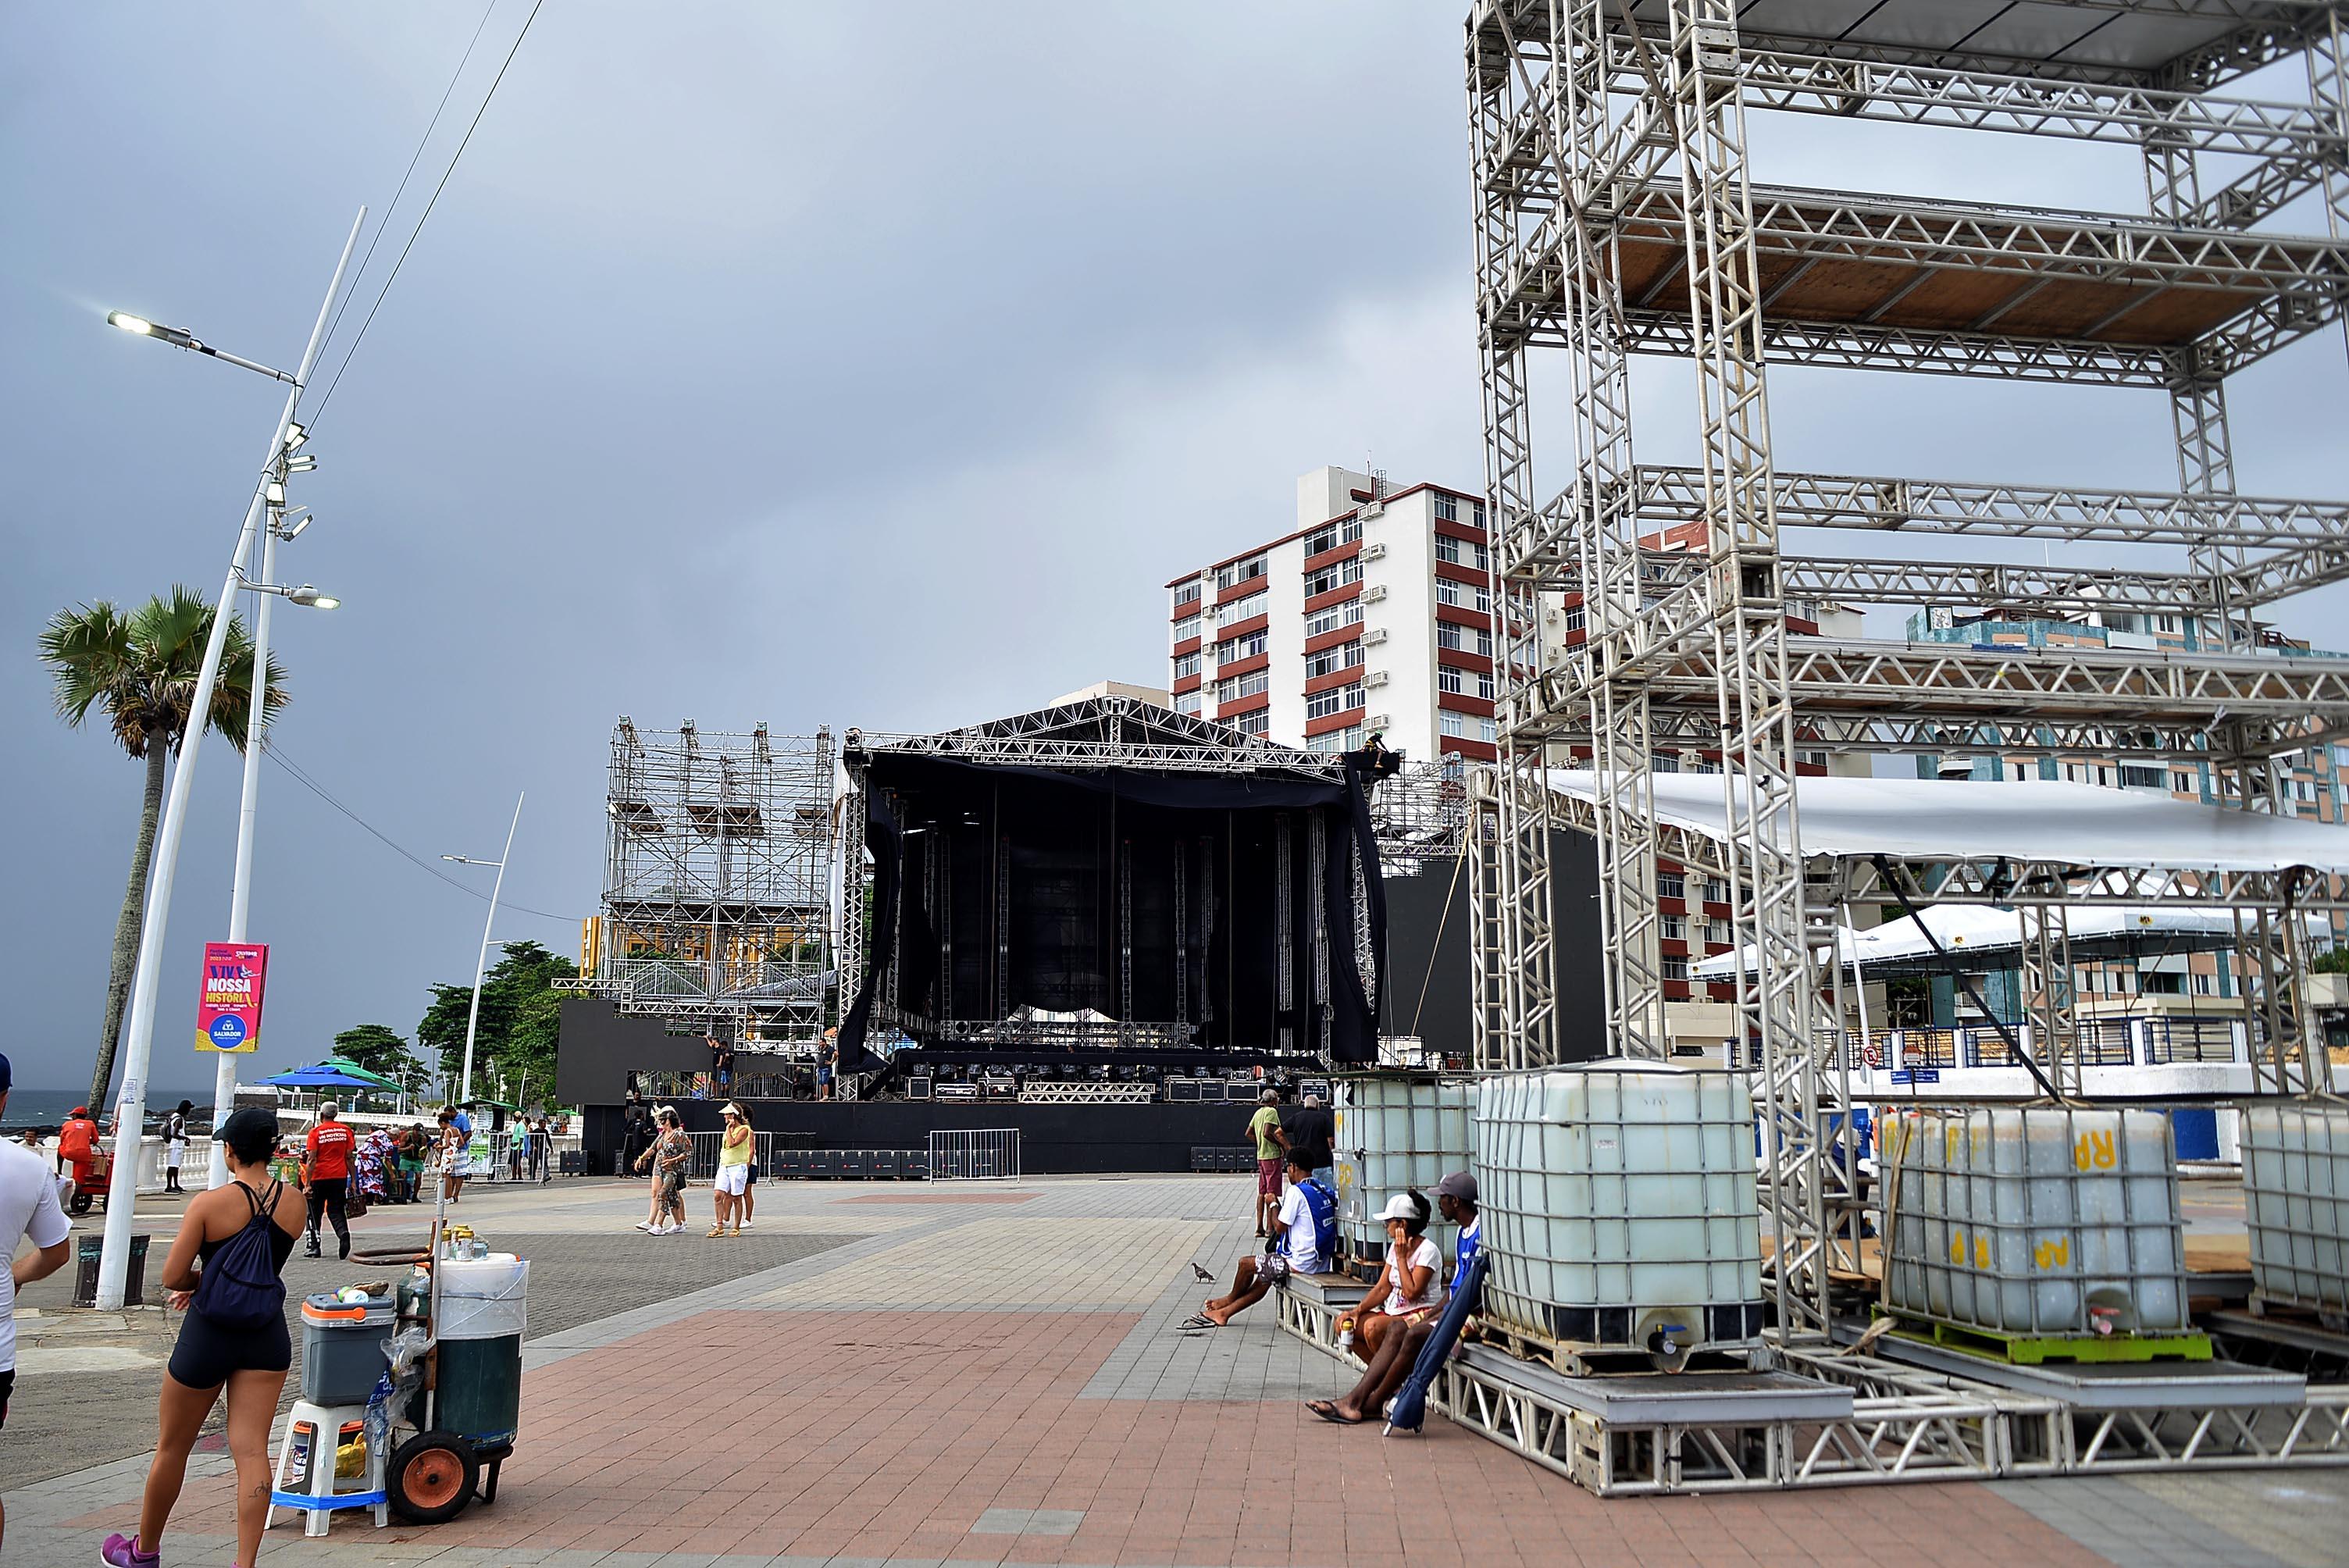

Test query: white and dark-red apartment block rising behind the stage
[1167,467,1496,761]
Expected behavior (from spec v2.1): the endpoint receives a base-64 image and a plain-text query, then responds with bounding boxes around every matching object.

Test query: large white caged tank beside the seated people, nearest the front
[1475,1059,1762,1370]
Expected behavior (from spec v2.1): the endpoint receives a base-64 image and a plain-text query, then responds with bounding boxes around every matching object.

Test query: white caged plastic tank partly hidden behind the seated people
[1337,1075,1473,1272]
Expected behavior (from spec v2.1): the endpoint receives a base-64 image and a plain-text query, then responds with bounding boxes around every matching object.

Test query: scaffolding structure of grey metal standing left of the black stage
[578,716,834,1052]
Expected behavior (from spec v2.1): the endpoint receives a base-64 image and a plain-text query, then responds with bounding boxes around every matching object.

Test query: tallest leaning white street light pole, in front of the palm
[96,207,366,1312]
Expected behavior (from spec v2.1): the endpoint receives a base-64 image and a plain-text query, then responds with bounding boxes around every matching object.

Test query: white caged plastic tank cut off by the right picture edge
[2244,1103,2349,1317]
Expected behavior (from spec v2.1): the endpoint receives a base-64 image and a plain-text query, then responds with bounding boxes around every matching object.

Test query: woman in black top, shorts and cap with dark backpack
[98,1106,303,1568]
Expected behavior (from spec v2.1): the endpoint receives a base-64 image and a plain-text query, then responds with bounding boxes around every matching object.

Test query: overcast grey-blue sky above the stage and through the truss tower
[0,0,2344,1089]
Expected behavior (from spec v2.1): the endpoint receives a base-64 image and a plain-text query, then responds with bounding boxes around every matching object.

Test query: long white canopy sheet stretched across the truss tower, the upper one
[1550,768,2349,873]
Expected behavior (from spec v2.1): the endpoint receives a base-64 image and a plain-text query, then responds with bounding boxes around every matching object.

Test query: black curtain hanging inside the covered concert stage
[841,754,1386,1071]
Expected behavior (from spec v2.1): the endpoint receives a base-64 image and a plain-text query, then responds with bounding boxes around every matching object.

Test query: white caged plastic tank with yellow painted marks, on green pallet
[1879,1108,2191,1340]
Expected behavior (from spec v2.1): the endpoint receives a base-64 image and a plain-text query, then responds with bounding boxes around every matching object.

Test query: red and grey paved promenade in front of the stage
[0,1176,2349,1568]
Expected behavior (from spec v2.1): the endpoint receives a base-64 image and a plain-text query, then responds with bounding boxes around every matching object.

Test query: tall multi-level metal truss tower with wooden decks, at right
[1468,0,2349,1338]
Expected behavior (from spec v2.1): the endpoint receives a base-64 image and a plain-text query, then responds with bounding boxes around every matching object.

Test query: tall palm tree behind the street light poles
[40,586,287,1106]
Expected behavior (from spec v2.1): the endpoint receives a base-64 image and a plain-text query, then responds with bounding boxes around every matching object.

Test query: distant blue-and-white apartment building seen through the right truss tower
[1907,606,2349,1017]
